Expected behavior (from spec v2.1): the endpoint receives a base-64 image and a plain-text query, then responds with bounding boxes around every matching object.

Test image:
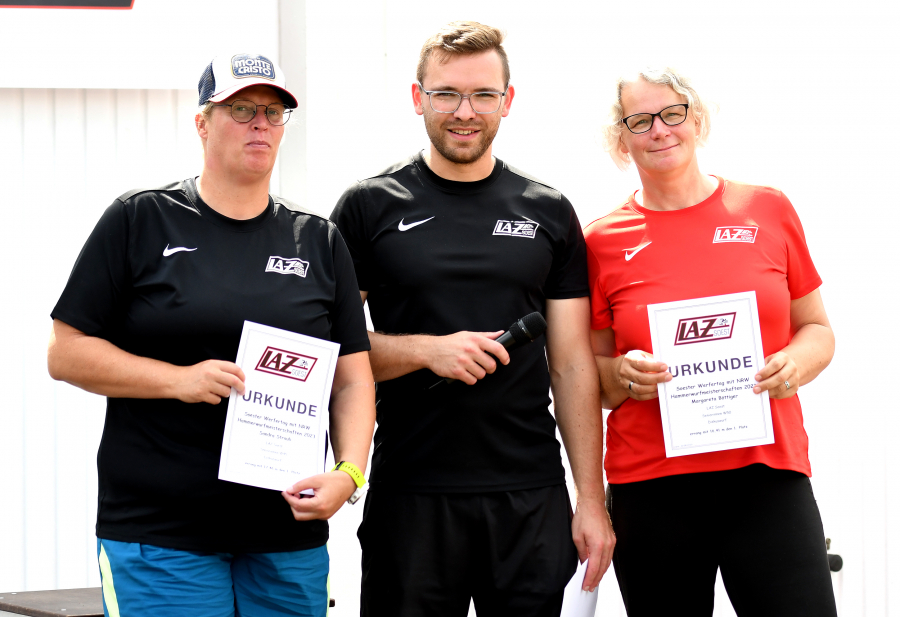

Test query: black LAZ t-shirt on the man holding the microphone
[331,154,588,492]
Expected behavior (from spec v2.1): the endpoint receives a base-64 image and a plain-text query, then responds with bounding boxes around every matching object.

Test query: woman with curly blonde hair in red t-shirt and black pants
[585,69,836,617]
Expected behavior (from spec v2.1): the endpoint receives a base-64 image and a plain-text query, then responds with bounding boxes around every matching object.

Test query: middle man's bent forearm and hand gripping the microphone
[359,291,509,386]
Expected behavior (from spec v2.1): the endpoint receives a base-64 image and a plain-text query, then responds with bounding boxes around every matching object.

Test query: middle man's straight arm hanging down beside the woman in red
[547,298,616,590]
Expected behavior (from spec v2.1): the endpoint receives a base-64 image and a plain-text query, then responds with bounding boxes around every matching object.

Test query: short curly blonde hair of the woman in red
[603,67,711,170]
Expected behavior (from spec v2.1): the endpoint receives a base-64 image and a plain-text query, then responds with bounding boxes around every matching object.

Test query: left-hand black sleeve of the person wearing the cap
[50,200,131,339]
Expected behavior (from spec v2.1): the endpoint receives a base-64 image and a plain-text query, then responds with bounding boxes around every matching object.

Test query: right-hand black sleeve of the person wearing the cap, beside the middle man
[328,225,371,356]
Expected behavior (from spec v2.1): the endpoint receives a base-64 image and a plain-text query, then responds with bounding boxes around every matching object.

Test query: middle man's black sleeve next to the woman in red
[544,195,590,300]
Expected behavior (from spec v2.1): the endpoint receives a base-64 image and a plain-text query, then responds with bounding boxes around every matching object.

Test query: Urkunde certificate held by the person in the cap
[219,321,341,491]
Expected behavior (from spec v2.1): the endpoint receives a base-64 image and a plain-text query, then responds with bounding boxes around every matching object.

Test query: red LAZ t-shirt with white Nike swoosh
[584,178,822,484]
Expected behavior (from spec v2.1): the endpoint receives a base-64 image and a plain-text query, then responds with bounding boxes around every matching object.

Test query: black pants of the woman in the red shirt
[608,465,837,617]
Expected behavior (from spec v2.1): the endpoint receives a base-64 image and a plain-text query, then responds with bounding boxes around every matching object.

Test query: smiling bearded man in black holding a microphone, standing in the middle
[331,22,615,617]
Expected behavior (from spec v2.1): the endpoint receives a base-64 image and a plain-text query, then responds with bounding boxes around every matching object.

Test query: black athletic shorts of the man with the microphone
[358,485,578,617]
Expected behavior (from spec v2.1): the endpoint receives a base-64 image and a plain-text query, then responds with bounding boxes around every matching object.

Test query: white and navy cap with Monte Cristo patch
[197,53,297,108]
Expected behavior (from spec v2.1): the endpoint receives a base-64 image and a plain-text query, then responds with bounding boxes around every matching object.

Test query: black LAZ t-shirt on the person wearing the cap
[52,179,369,552]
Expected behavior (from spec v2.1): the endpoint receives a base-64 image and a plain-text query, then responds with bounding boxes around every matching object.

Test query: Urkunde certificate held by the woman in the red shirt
[647,291,775,458]
